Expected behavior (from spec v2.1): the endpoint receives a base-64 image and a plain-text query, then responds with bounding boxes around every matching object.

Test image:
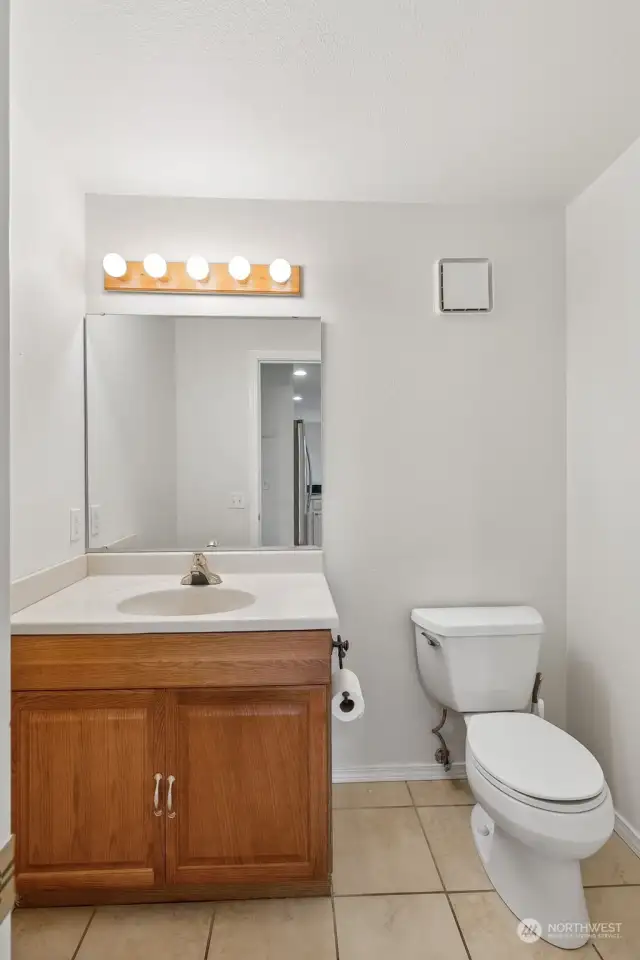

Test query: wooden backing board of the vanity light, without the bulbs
[104,260,302,297]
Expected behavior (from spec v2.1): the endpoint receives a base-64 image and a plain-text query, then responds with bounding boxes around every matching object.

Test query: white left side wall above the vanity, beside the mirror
[11,110,84,578]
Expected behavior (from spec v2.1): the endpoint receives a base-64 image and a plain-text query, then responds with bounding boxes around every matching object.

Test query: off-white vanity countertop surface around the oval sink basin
[11,573,338,634]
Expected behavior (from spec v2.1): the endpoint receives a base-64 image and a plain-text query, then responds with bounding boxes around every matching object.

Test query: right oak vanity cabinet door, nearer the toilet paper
[167,687,329,884]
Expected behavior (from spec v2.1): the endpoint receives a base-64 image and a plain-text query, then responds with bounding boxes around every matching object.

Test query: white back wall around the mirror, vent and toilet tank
[86,196,565,769]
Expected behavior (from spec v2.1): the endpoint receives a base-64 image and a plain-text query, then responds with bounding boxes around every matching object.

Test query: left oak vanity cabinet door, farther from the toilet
[13,690,165,893]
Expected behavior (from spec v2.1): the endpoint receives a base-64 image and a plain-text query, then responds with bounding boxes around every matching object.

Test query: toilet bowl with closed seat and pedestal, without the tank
[465,713,614,949]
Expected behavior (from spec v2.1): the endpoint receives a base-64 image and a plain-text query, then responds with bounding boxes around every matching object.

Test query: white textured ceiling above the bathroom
[12,0,640,202]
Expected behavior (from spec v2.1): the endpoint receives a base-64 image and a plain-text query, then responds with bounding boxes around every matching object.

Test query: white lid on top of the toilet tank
[411,607,544,637]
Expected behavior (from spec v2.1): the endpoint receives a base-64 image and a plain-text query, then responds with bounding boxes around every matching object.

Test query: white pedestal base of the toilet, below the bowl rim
[471,803,589,950]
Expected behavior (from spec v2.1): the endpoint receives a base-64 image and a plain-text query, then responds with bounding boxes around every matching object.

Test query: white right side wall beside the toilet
[567,141,640,842]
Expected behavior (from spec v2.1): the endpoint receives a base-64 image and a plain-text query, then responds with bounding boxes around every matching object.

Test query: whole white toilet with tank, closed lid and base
[411,607,614,949]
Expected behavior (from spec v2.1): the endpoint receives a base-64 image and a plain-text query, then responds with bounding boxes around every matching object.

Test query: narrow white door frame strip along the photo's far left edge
[0,0,11,960]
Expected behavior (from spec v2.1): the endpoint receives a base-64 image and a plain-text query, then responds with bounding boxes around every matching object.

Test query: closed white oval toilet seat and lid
[467,713,606,813]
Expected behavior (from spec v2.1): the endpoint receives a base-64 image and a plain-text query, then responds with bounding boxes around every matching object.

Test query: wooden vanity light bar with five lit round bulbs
[103,253,302,297]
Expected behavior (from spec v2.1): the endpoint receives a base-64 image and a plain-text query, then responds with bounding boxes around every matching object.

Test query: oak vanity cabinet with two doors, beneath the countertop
[12,631,331,905]
